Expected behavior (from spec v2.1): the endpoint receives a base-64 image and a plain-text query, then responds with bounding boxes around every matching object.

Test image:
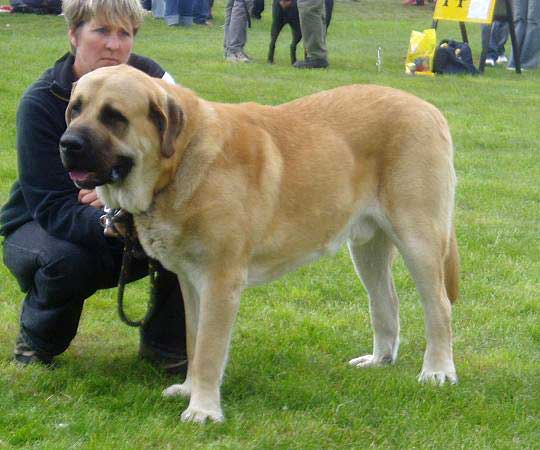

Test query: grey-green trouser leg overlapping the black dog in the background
[297,0,327,60]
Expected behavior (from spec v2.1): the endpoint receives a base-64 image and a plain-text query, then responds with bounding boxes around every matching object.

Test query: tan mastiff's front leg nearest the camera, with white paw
[181,268,244,423]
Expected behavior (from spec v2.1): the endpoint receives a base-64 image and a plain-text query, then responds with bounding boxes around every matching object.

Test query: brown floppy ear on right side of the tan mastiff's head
[149,95,184,158]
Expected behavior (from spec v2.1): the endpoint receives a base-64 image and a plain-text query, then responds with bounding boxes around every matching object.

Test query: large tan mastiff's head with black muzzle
[60,66,185,211]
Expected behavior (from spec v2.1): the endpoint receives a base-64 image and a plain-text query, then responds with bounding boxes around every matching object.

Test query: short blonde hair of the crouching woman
[62,0,144,34]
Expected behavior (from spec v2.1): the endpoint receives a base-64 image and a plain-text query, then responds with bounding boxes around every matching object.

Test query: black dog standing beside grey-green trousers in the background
[268,0,334,64]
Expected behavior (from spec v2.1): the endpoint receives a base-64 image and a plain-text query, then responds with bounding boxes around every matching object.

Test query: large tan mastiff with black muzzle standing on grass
[60,66,458,422]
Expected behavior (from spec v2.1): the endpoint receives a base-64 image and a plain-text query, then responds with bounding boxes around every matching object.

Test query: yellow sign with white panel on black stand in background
[433,0,496,23]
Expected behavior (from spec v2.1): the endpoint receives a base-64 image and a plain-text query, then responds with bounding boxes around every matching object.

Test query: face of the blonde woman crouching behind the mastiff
[68,18,134,79]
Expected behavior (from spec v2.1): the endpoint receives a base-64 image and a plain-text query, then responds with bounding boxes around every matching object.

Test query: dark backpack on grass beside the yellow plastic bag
[433,39,478,75]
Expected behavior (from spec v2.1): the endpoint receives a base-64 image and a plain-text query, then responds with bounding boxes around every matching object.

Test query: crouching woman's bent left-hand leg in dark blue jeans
[4,222,135,355]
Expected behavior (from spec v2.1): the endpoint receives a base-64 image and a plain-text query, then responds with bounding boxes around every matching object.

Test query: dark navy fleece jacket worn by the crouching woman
[0,53,165,248]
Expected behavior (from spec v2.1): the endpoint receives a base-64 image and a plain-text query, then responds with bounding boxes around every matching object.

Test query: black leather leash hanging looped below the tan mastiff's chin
[100,208,158,327]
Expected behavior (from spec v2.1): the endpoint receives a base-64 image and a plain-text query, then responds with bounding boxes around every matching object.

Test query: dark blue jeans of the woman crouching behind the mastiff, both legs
[4,222,185,355]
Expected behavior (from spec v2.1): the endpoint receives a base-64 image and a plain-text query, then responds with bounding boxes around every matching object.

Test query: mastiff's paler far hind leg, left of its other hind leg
[348,229,399,367]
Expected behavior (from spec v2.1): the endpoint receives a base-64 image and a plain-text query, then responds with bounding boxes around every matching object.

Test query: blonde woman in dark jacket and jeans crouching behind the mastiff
[0,0,186,372]
